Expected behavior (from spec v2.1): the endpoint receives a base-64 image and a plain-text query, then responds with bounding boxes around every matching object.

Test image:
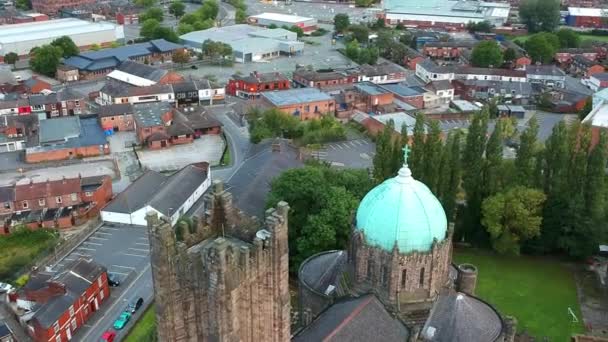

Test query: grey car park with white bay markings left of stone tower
[55,224,154,341]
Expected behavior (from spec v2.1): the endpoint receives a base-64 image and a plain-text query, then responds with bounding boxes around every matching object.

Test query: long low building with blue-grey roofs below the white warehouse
[63,39,184,79]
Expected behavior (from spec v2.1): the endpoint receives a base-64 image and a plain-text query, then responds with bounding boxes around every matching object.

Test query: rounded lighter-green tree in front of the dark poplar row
[482,186,546,254]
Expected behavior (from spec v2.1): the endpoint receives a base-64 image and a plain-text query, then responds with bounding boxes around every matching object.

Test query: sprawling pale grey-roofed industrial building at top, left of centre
[180,24,304,63]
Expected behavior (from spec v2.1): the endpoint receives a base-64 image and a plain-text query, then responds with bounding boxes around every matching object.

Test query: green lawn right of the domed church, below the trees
[454,249,584,341]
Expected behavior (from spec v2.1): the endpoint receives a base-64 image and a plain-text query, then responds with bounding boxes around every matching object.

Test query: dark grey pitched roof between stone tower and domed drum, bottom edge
[292,295,408,342]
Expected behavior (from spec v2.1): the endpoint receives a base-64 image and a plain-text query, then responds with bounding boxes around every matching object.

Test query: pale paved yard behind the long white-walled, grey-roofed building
[137,135,226,172]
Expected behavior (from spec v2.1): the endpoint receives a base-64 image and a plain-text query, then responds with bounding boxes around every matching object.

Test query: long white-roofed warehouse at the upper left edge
[0,18,124,56]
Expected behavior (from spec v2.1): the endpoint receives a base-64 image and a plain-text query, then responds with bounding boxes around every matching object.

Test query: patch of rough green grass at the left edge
[0,228,59,281]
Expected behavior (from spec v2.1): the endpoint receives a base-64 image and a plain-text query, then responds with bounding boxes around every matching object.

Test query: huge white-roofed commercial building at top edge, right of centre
[383,0,511,30]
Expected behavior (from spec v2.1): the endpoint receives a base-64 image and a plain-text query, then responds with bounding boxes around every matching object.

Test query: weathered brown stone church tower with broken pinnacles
[148,182,290,342]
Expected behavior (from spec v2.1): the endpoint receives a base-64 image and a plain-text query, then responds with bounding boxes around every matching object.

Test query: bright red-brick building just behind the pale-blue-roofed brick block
[226,71,290,99]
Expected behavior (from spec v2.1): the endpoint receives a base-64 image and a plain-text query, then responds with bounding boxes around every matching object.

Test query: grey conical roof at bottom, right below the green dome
[421,292,503,342]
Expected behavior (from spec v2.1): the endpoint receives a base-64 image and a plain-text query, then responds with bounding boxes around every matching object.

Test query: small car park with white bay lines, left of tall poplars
[312,138,376,169]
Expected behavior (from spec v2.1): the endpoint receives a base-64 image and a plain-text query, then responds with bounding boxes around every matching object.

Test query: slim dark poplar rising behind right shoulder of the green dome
[420,120,443,193]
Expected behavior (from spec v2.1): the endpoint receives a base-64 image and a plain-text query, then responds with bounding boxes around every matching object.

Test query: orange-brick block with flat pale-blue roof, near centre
[261,88,336,120]
